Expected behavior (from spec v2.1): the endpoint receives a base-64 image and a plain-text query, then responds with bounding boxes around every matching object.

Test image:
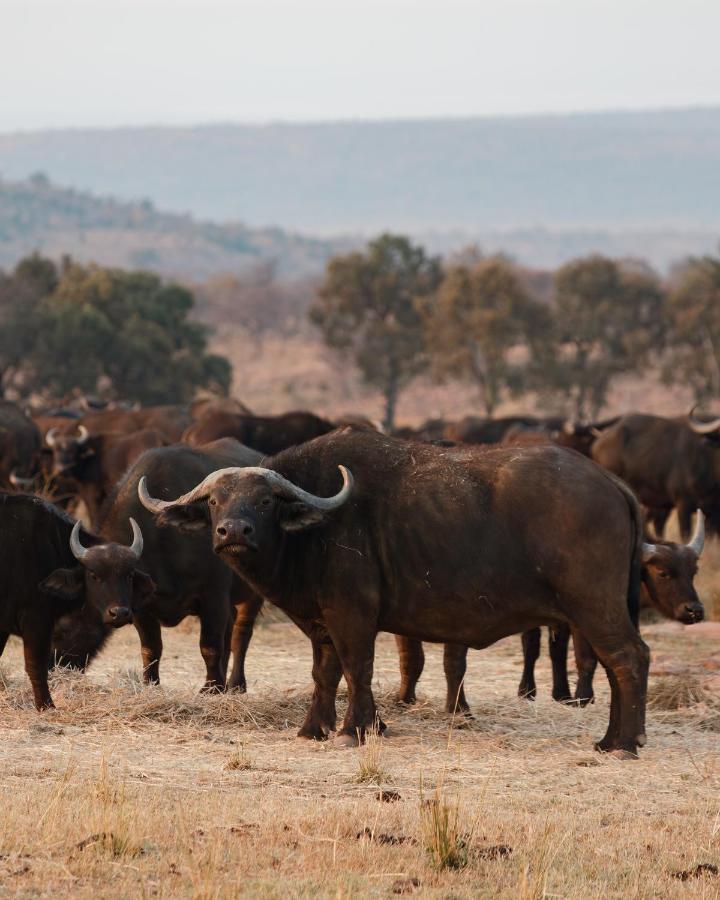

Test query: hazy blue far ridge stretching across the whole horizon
[0,108,720,233]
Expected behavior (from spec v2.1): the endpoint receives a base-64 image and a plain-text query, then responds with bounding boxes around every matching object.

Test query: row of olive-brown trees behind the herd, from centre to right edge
[309,234,720,428]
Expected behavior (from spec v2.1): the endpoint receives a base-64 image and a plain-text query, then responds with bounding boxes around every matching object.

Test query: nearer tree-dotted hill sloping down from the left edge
[0,175,336,278]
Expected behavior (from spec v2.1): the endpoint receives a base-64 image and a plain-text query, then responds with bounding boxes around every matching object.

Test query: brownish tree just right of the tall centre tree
[427,257,548,416]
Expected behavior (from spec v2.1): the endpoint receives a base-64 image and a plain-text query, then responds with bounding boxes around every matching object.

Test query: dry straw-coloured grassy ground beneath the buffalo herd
[0,528,720,898]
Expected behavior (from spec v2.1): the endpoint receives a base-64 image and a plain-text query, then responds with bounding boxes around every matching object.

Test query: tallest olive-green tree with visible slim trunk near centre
[310,234,442,429]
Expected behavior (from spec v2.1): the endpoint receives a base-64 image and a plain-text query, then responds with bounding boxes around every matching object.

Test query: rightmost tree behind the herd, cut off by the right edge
[663,256,720,403]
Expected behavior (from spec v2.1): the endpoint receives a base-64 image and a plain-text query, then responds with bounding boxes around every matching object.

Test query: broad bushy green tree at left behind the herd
[0,258,231,403]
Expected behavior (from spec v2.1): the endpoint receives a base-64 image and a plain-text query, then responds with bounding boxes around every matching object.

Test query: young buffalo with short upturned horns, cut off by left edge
[0,493,154,709]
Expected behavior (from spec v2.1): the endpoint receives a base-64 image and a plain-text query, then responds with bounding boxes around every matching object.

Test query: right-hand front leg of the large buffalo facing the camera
[324,607,386,746]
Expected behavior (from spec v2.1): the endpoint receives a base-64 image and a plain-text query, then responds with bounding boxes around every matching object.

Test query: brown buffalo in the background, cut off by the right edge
[592,413,720,540]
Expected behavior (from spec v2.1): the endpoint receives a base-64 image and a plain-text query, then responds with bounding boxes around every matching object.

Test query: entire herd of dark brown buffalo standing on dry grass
[0,398,720,758]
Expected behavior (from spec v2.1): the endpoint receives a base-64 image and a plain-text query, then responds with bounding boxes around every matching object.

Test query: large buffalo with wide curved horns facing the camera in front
[138,429,649,755]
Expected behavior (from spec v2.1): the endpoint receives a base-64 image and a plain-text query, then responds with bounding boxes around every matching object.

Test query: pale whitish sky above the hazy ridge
[0,0,720,131]
